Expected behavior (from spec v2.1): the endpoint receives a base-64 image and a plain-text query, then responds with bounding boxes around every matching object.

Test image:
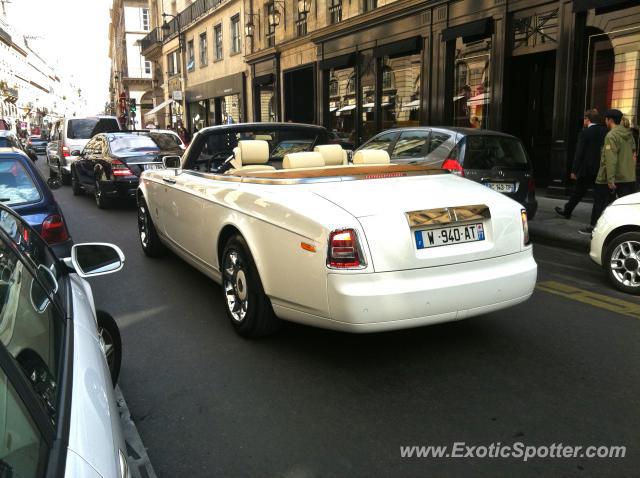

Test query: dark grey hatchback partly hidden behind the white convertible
[358,127,538,219]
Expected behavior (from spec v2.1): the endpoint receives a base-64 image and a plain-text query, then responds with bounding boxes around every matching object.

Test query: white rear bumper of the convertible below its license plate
[322,248,537,332]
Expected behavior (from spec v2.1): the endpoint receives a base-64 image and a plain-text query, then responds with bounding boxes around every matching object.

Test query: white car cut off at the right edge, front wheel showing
[589,193,640,294]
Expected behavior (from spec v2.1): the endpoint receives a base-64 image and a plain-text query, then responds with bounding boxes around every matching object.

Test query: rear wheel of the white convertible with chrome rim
[220,234,282,338]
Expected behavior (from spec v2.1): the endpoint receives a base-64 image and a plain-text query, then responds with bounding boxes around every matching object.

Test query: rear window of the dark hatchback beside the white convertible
[464,135,528,169]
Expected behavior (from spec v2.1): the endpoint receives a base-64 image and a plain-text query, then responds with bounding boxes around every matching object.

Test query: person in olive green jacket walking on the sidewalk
[579,110,636,234]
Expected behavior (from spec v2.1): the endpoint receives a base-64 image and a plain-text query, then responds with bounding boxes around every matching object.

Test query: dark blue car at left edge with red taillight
[0,147,73,257]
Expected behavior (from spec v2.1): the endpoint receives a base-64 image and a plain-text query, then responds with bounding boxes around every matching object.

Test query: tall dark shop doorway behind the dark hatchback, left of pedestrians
[504,51,556,186]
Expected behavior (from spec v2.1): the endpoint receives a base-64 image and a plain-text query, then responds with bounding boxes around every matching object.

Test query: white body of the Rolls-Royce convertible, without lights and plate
[140,167,537,332]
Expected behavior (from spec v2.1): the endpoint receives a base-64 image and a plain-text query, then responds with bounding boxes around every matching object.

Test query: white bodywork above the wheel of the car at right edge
[589,193,640,265]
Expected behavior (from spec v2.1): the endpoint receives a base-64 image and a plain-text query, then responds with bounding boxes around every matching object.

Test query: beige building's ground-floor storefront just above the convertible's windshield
[186,73,246,134]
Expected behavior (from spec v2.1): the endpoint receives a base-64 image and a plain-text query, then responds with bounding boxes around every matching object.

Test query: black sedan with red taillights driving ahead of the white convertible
[71,132,183,209]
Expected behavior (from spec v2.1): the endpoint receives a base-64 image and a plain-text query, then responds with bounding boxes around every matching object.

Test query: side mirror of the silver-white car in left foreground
[71,242,124,277]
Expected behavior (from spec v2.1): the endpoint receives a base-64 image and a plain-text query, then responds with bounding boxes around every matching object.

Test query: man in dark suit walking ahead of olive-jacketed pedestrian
[556,109,607,219]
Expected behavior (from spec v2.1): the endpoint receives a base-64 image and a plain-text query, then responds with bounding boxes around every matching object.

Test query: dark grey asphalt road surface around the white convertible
[37,158,640,477]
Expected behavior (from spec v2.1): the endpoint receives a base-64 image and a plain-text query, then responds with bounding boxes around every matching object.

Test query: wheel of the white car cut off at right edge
[602,232,640,295]
